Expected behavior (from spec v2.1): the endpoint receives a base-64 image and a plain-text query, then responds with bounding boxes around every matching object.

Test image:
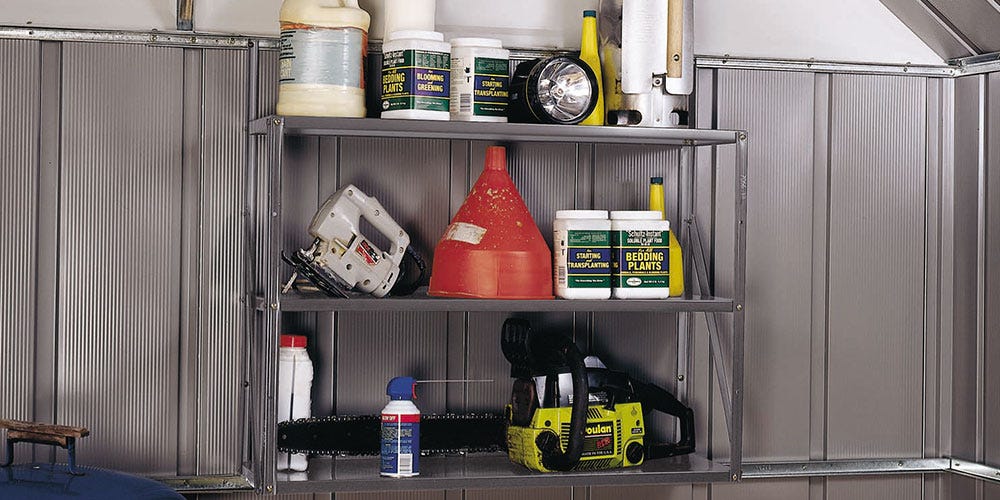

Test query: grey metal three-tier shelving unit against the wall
[244,116,747,493]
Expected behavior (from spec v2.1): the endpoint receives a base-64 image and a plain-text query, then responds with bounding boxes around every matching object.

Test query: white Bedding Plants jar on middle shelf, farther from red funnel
[611,210,670,299]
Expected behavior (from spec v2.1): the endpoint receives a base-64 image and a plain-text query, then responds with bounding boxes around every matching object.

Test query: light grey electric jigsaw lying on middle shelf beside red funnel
[281,184,426,297]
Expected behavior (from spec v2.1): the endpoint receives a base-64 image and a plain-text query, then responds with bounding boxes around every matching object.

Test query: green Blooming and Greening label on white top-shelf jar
[382,50,451,111]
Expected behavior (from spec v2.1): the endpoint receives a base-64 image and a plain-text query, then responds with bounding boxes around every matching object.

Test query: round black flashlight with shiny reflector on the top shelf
[508,56,598,125]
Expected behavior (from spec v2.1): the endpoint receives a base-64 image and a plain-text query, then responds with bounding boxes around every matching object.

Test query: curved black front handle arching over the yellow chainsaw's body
[539,335,590,471]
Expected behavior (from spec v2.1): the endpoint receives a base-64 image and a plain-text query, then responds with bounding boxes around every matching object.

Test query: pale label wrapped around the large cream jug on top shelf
[278,23,368,89]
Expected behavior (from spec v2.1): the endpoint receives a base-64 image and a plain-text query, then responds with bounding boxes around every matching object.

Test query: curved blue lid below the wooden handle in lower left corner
[0,464,184,500]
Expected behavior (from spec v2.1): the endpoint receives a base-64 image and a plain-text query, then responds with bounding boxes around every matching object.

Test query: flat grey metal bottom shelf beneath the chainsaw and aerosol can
[276,453,729,493]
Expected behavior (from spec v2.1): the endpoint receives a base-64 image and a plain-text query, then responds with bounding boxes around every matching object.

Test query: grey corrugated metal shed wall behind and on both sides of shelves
[0,33,1000,499]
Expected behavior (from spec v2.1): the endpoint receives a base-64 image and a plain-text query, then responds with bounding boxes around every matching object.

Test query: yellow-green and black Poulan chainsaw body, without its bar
[500,318,695,472]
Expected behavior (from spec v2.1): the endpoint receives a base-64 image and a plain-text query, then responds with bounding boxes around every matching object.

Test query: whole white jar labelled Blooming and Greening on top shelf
[382,31,451,120]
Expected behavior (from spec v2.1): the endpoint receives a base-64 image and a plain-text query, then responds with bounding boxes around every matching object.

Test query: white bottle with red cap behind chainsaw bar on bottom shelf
[278,335,313,471]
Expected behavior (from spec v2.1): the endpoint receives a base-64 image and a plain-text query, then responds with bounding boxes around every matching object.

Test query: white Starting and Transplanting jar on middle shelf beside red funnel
[552,210,611,299]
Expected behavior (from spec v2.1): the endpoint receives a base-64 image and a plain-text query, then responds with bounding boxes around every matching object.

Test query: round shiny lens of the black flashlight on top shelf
[538,60,593,122]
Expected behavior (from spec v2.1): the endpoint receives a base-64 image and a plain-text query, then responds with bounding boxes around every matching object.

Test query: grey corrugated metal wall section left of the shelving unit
[0,40,247,475]
